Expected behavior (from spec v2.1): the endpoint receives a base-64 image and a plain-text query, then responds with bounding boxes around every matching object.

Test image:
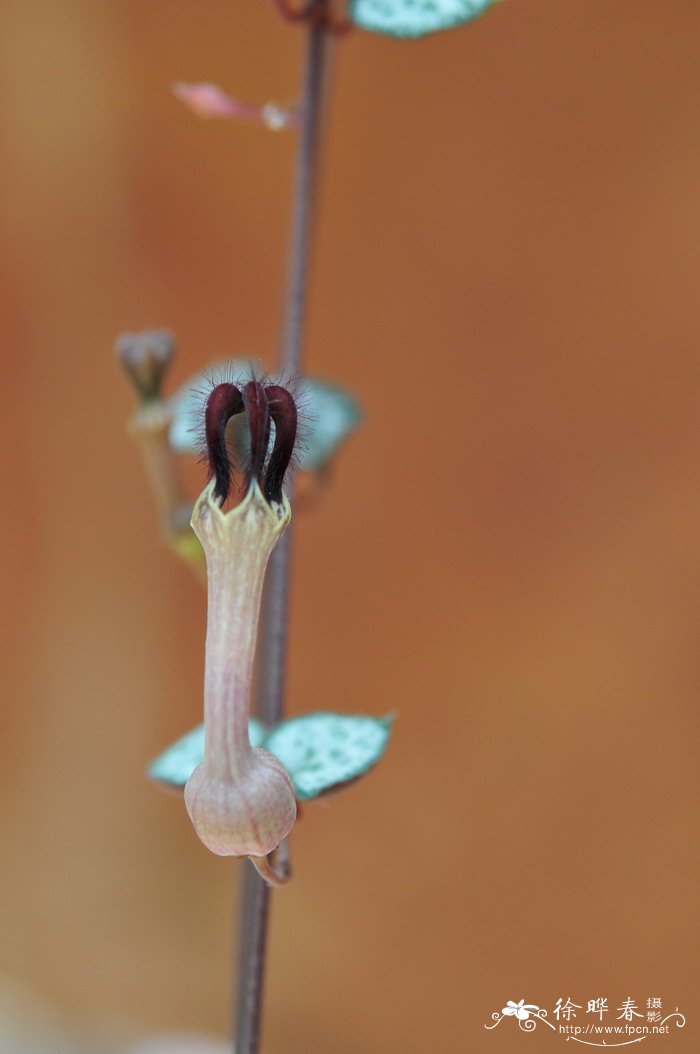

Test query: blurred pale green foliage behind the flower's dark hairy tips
[169,359,362,471]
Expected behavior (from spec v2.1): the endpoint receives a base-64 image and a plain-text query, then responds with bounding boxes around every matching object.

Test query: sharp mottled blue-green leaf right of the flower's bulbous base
[265,711,392,801]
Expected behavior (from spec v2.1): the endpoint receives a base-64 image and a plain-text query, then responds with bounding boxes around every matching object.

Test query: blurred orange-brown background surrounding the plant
[0,0,700,1054]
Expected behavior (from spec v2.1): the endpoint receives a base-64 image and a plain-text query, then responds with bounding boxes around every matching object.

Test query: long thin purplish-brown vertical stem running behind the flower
[235,0,330,1054]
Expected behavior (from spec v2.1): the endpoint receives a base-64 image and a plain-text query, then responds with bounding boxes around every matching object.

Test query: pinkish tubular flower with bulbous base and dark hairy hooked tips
[184,380,296,884]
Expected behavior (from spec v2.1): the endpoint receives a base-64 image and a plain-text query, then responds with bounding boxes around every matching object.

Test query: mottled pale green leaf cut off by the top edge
[350,0,495,38]
